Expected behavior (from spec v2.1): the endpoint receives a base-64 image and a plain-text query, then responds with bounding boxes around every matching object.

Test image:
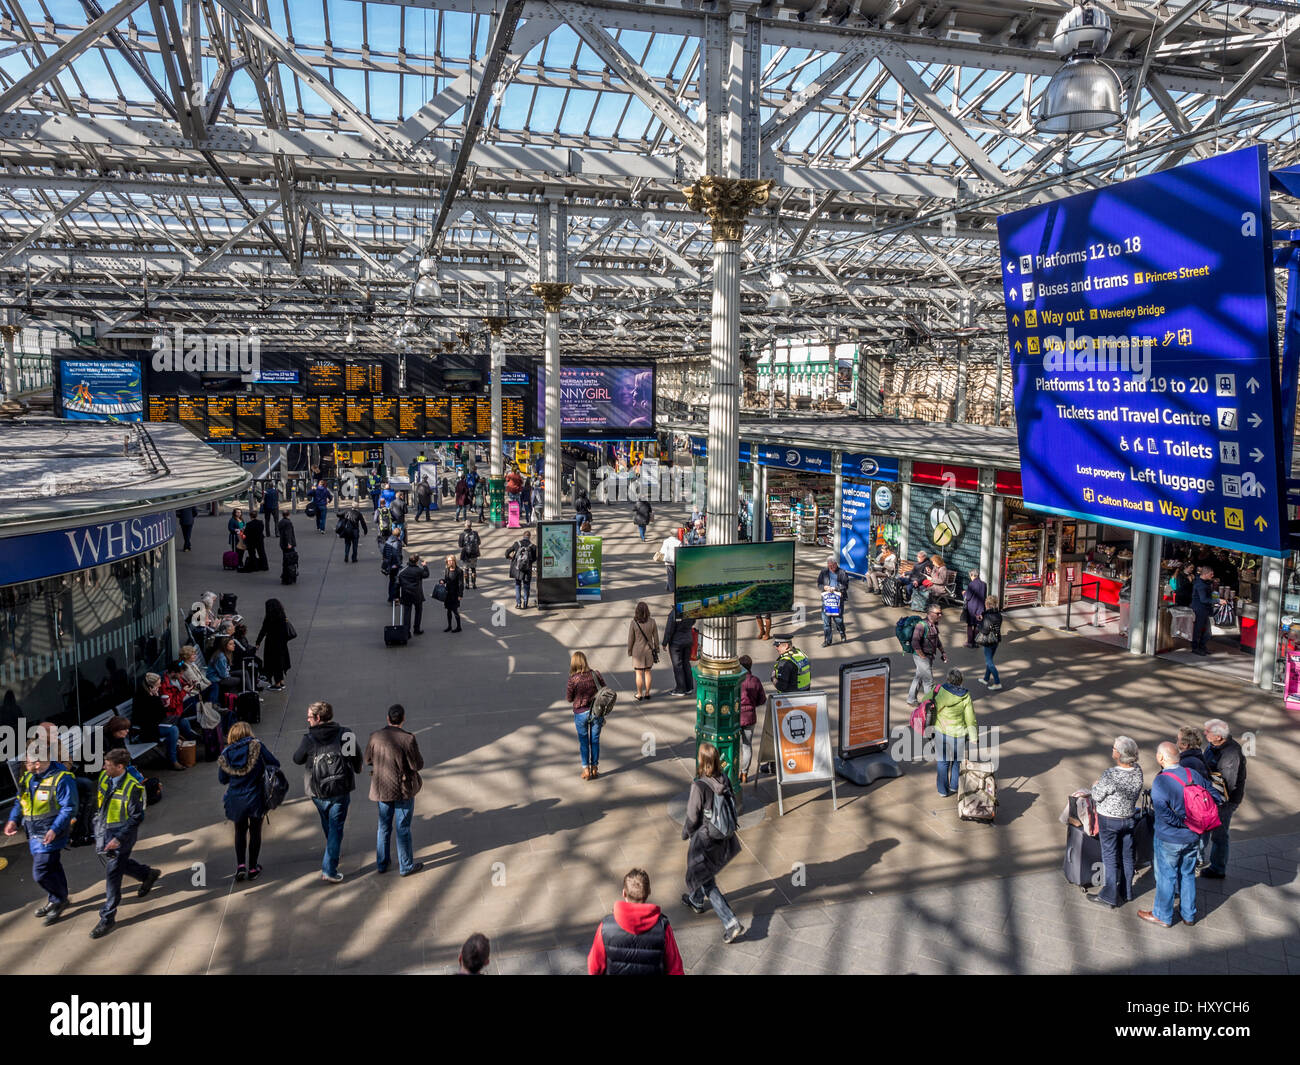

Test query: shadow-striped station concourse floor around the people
[0,505,1300,973]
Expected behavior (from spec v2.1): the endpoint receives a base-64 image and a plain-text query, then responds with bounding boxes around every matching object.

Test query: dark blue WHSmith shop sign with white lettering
[0,510,176,584]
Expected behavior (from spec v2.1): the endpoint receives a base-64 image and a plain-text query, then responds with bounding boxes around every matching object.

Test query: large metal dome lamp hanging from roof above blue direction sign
[1034,0,1125,134]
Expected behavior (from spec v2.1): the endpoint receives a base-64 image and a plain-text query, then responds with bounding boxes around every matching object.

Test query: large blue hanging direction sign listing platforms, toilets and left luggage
[997,148,1286,557]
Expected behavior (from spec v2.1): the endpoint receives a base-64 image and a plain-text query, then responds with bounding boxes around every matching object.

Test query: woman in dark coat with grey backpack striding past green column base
[681,743,745,943]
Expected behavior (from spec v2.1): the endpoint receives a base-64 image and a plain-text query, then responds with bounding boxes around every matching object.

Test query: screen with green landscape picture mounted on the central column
[675,540,794,618]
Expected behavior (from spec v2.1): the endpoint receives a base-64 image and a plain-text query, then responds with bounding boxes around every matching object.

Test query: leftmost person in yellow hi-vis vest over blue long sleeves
[4,740,78,925]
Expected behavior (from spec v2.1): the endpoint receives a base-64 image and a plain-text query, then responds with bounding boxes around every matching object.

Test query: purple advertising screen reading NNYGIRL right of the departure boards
[537,363,655,440]
